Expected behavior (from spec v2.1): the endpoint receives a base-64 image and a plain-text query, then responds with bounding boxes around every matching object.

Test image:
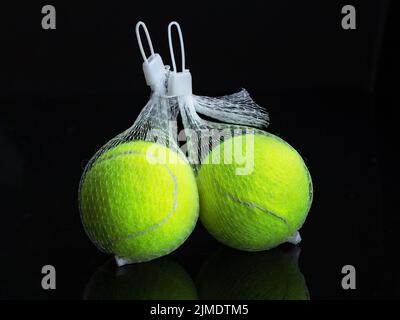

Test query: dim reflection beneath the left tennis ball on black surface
[84,257,197,300]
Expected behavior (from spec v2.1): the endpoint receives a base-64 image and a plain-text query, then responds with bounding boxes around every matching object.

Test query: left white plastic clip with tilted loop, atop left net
[136,21,166,86]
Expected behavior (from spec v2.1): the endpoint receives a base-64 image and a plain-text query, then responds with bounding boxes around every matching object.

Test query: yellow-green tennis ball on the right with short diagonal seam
[197,133,312,251]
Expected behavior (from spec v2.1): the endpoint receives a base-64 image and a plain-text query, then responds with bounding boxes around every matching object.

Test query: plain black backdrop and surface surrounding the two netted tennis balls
[0,0,400,299]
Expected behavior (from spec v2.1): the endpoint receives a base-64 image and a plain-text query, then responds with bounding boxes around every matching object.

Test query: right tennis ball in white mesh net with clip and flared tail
[167,22,313,251]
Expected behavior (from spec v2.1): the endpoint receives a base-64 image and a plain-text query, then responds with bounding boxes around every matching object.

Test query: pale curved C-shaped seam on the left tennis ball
[86,150,178,245]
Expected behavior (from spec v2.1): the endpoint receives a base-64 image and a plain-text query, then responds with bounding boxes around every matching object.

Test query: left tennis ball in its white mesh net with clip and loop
[79,22,199,265]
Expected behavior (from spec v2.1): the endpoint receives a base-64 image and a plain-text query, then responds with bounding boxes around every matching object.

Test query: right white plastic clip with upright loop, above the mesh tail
[167,21,192,97]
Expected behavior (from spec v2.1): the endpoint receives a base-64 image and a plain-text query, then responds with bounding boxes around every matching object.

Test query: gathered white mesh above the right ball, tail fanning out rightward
[175,89,268,171]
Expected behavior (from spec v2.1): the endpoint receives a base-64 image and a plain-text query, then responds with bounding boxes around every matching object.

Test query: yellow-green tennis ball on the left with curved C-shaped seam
[80,141,198,262]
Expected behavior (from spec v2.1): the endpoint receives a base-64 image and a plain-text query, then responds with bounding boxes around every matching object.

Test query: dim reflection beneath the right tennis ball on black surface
[196,247,309,300]
